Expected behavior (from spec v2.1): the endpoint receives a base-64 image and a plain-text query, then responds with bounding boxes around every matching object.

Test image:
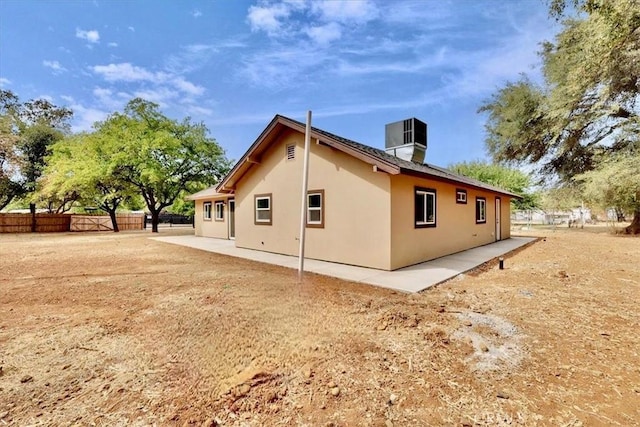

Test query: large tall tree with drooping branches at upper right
[480,0,640,234]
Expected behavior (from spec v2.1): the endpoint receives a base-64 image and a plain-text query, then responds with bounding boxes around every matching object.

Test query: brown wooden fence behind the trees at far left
[0,213,145,233]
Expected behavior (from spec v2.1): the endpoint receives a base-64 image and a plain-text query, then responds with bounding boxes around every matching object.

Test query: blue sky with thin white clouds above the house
[0,0,558,166]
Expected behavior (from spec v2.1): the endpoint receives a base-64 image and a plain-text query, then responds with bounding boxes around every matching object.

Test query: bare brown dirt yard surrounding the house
[0,229,640,427]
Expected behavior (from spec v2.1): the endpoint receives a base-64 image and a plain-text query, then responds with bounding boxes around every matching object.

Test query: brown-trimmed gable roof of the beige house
[216,114,520,198]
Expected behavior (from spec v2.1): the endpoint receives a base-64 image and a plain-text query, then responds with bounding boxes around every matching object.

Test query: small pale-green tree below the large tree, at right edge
[575,153,640,234]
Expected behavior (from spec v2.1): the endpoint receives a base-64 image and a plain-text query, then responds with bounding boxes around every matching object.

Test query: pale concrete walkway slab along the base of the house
[152,235,536,292]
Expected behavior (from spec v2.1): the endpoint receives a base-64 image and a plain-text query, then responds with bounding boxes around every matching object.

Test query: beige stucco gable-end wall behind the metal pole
[235,130,391,269]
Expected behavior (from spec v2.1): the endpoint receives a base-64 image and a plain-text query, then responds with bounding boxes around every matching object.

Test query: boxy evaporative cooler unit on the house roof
[384,117,427,164]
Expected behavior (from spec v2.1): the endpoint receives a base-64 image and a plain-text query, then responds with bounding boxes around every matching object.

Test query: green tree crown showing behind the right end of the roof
[449,161,539,210]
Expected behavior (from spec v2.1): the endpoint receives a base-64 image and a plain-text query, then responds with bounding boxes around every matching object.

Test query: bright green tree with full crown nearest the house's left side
[96,98,230,232]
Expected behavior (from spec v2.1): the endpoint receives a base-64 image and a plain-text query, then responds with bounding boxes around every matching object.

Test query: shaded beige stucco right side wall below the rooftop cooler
[391,175,509,269]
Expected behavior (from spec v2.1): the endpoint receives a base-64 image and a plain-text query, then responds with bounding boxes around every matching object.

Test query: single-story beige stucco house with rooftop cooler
[189,115,518,270]
